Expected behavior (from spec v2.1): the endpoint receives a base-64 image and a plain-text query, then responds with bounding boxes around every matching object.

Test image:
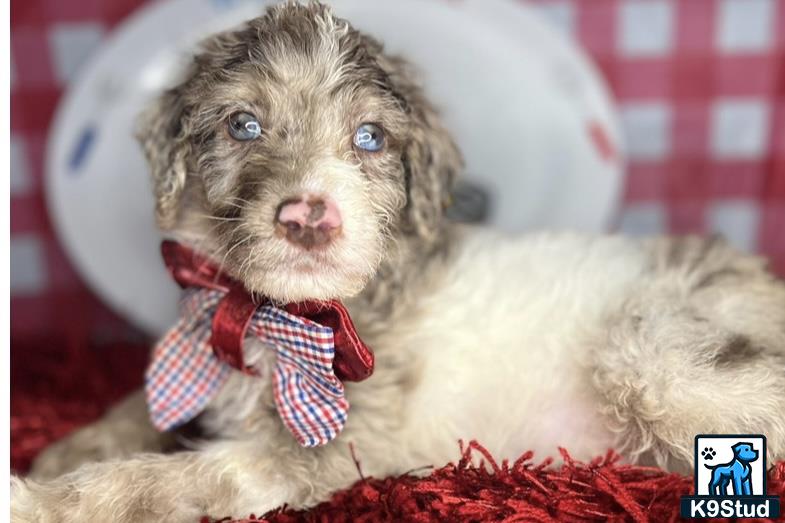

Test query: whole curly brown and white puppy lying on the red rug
[13,3,785,522]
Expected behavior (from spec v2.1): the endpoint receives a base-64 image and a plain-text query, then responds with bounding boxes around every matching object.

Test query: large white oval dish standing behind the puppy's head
[46,0,622,334]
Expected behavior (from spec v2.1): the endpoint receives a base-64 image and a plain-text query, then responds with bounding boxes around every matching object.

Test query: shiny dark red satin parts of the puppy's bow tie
[161,240,374,381]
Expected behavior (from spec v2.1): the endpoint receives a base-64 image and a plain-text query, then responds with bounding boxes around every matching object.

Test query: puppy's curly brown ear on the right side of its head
[385,59,463,243]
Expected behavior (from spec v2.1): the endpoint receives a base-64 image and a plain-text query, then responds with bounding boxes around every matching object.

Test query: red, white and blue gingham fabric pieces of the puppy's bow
[145,289,349,447]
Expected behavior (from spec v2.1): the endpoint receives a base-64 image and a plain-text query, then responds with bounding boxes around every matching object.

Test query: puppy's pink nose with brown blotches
[275,195,343,250]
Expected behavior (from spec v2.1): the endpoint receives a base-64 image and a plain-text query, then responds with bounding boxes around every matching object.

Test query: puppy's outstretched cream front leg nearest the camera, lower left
[11,434,357,523]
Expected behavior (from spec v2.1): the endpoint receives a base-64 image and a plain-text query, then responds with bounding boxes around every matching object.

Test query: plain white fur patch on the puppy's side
[388,229,645,466]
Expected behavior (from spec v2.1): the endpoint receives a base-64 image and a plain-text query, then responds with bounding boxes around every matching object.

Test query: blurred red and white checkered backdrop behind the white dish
[10,0,785,350]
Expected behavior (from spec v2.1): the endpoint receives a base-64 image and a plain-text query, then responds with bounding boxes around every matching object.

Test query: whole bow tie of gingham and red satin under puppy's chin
[145,241,373,447]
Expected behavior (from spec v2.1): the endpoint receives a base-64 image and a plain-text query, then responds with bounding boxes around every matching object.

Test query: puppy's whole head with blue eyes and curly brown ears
[140,3,461,301]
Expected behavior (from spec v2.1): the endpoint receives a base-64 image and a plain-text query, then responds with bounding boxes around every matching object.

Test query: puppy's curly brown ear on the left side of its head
[136,79,191,230]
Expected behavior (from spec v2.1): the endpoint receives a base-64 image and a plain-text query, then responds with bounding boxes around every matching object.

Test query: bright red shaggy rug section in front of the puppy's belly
[208,441,785,523]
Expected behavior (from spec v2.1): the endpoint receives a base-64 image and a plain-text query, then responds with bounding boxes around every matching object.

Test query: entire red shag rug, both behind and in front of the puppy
[11,346,785,523]
